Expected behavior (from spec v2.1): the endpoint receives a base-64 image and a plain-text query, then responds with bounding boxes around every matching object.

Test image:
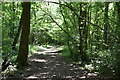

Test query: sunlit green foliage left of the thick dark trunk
[2,2,22,67]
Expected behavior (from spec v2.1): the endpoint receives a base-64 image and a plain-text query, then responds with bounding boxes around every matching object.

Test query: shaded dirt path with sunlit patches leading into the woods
[1,46,116,80]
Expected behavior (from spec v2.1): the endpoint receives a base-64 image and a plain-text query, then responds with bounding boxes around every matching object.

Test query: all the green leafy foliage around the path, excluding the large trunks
[2,2,120,76]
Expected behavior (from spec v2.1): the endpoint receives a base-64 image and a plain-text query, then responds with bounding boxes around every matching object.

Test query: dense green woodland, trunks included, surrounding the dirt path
[1,2,120,80]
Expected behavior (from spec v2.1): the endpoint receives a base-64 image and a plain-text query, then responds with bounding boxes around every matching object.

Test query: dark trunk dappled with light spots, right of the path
[78,3,88,61]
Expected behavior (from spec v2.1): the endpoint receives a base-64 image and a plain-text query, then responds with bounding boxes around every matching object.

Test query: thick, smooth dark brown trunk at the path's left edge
[16,2,30,67]
